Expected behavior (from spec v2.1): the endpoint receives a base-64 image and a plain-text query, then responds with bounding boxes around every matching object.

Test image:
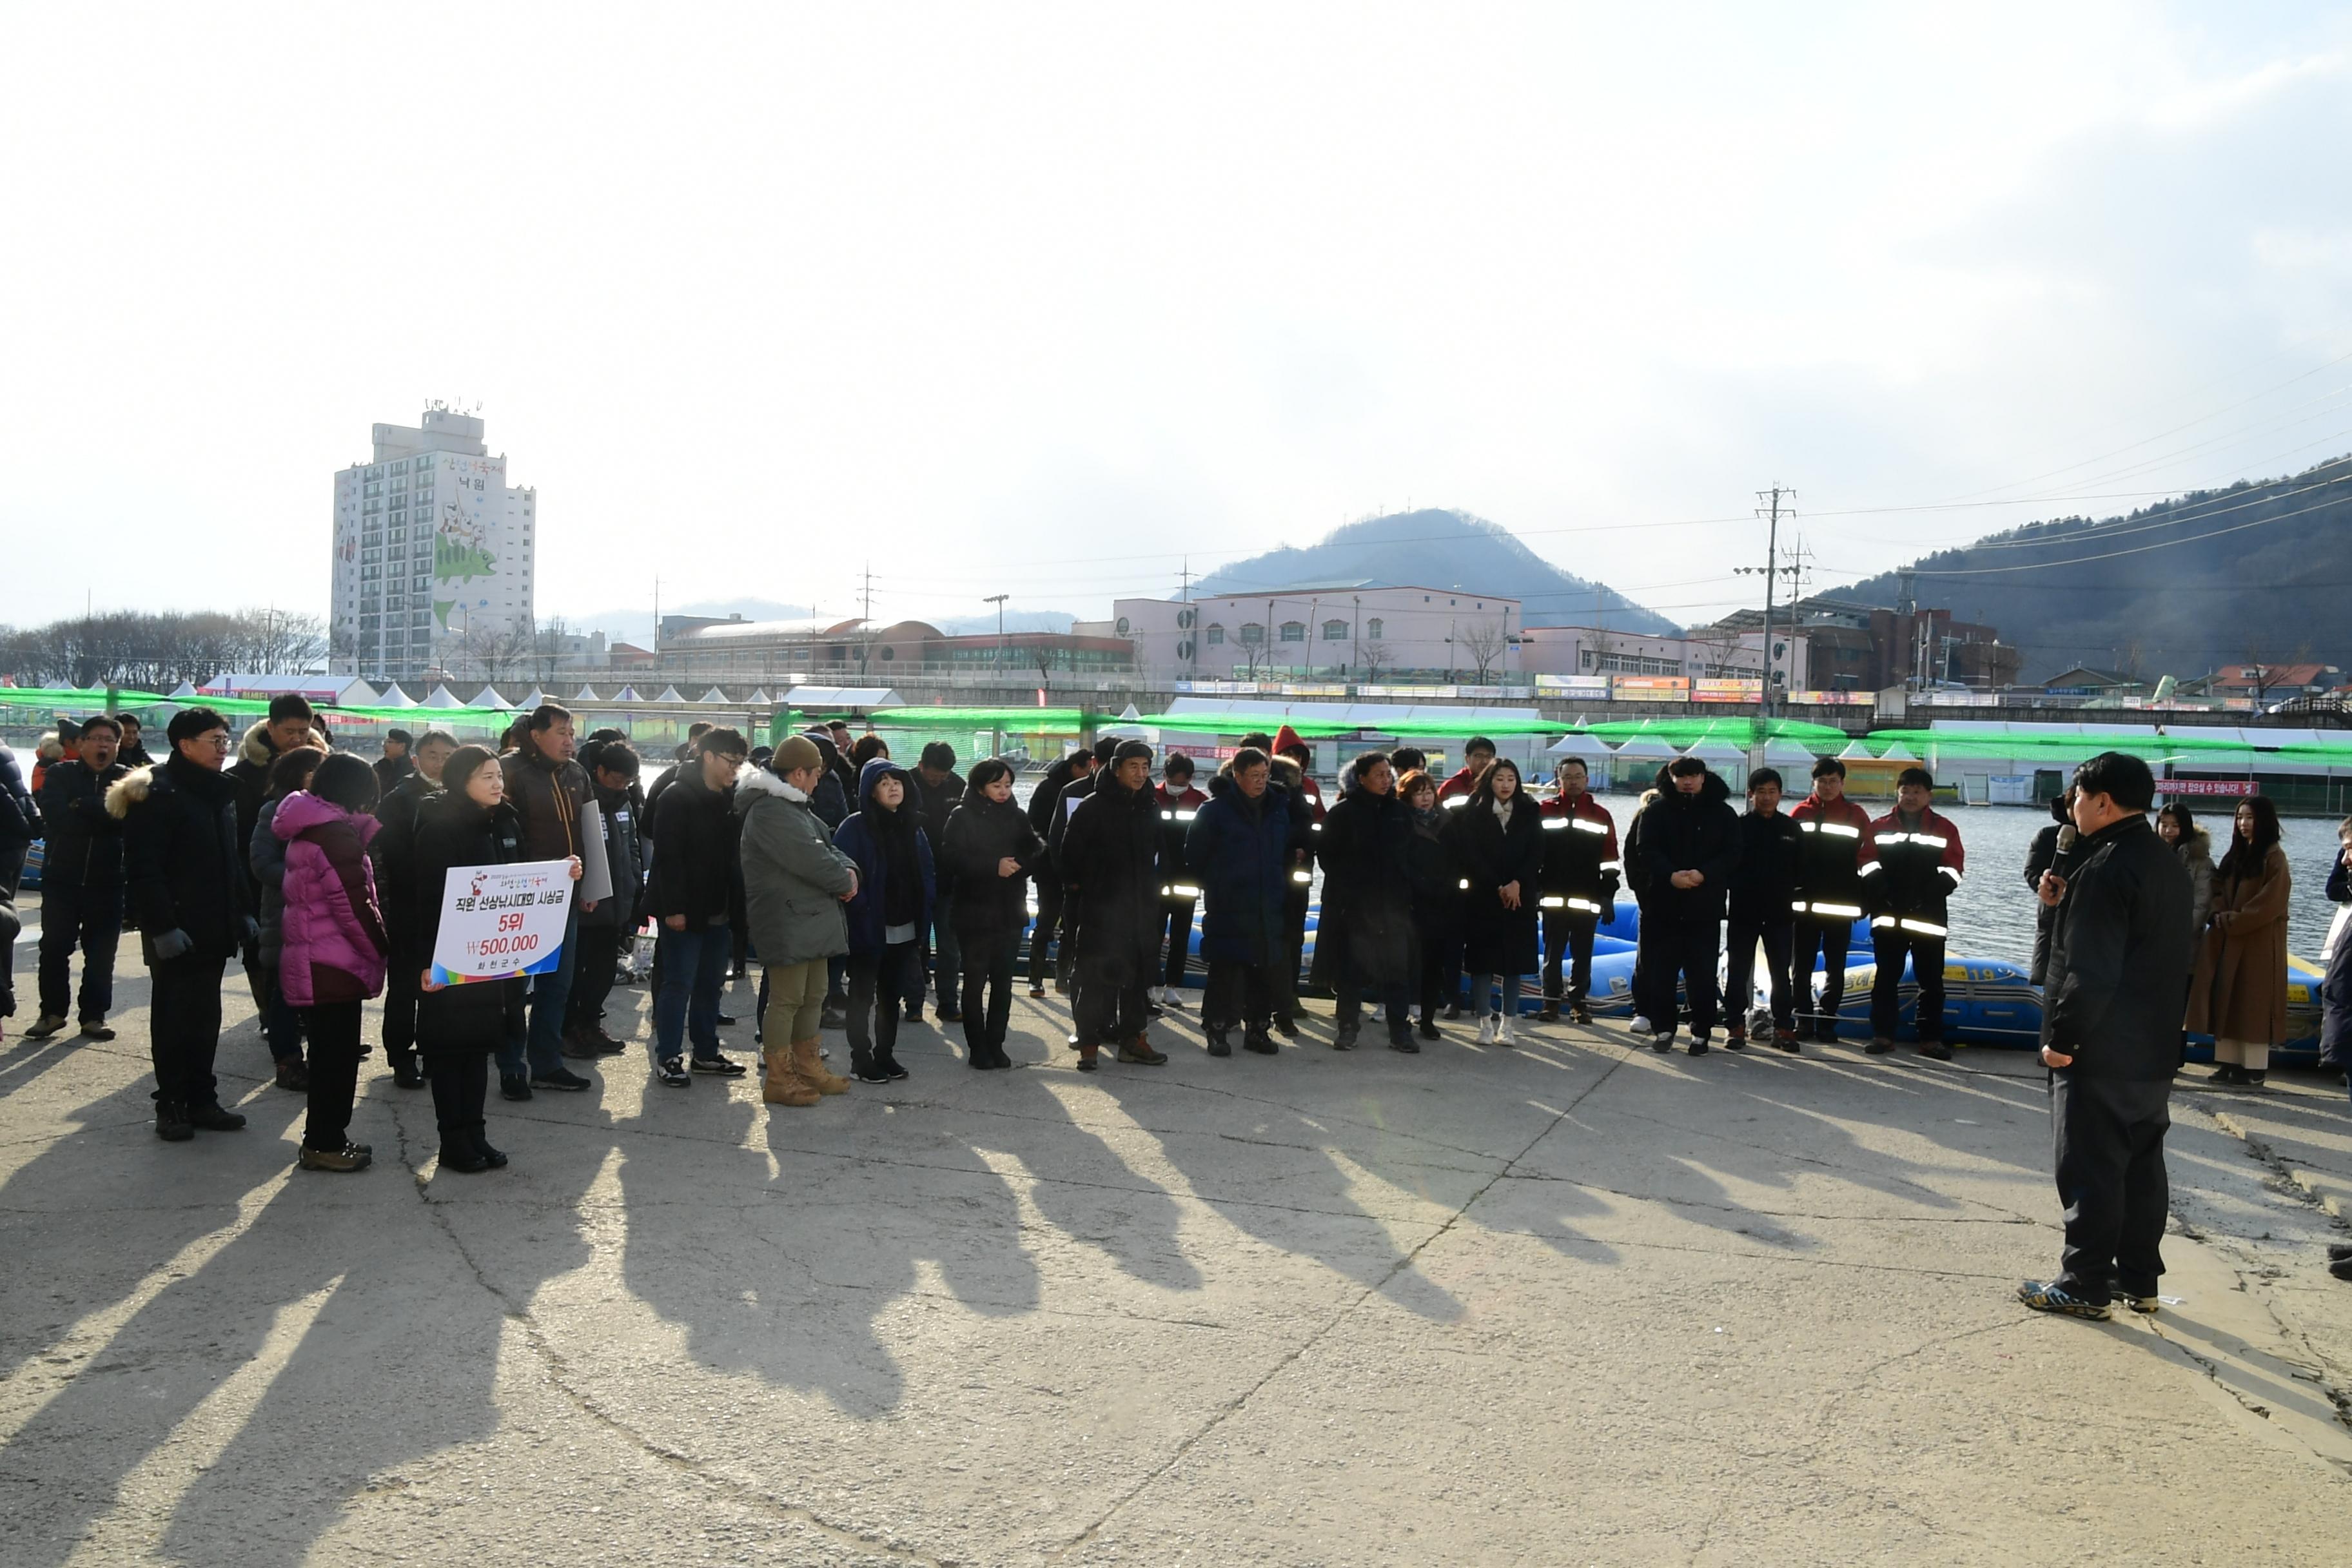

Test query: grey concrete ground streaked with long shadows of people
[0,907,2352,1568]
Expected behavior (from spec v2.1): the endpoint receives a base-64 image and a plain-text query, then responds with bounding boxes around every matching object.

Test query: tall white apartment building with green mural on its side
[327,404,538,681]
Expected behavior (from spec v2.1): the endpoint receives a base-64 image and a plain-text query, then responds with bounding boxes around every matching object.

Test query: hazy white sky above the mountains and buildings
[0,0,2352,623]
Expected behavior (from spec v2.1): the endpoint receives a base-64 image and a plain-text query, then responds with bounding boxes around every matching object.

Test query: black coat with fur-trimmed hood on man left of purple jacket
[106,752,259,968]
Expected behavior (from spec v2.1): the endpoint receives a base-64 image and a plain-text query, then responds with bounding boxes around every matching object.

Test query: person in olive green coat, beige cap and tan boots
[736,736,859,1105]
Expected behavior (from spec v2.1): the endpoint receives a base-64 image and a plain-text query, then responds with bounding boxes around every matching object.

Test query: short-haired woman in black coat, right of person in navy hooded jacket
[939,757,1044,1067]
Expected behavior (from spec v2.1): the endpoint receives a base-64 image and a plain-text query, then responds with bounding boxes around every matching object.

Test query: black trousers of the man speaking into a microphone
[2051,1072,2173,1302]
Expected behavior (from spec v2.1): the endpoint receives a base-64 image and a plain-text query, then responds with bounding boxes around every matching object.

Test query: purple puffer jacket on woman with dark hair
[271,790,391,1006]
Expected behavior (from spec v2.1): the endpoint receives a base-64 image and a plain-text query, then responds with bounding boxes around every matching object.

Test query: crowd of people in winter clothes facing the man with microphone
[0,696,2352,1241]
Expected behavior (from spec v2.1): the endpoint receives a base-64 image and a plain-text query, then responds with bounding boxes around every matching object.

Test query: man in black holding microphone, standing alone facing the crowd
[2018,752,2190,1319]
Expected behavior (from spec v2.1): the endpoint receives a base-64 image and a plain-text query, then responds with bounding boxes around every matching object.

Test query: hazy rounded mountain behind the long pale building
[1193,508,1680,634]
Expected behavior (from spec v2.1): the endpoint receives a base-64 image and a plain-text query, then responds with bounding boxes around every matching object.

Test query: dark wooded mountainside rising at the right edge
[1823,456,2352,681]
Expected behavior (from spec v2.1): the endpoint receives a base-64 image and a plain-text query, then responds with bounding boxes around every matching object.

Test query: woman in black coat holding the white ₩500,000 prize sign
[407,745,525,1171]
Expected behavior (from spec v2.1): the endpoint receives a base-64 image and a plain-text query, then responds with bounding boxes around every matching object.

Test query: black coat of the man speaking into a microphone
[2041,814,2195,1081]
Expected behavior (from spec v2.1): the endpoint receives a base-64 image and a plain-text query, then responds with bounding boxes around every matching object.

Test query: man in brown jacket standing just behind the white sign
[498,703,605,1100]
